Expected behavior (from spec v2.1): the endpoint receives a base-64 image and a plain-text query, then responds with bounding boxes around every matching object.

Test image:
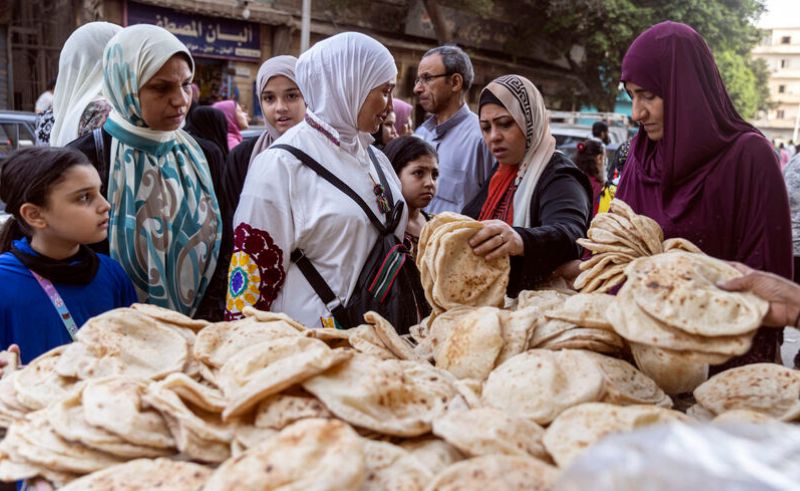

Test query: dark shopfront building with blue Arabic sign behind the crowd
[0,0,580,125]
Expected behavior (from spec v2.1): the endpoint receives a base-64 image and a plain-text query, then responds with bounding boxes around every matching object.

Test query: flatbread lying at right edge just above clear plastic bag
[694,363,800,421]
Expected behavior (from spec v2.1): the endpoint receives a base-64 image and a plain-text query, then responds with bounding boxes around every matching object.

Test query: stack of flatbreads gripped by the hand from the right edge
[606,251,768,394]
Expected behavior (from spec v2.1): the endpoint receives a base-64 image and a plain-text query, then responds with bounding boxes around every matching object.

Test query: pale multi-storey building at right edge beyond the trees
[753,26,800,144]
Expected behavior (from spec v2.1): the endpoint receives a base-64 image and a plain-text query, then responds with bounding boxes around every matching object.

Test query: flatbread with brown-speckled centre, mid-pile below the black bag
[303,355,457,436]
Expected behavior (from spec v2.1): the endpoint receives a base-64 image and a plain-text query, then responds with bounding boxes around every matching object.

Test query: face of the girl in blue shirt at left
[35,165,110,246]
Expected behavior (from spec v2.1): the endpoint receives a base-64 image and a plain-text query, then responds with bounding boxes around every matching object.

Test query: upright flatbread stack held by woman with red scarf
[417,212,510,317]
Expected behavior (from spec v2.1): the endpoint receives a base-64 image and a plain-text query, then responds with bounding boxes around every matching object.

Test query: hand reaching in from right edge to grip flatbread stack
[717,263,800,327]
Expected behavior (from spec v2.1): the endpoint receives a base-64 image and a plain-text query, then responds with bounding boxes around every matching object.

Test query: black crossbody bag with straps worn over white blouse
[270,144,431,334]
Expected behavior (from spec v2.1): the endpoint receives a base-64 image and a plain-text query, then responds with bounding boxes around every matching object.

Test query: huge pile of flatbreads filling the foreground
[0,206,800,491]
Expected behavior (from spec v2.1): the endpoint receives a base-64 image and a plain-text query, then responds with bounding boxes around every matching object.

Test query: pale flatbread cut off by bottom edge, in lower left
[62,459,212,491]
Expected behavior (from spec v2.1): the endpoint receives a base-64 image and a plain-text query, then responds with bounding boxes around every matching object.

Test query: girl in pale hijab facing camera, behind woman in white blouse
[221,55,306,226]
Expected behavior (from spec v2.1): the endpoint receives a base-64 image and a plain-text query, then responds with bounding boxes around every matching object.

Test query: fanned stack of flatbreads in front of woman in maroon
[574,199,701,293]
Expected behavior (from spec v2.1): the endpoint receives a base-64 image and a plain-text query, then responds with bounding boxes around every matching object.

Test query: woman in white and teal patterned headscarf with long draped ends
[73,25,224,318]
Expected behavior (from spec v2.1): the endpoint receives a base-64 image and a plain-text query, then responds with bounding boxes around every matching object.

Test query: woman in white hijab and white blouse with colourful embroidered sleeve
[226,32,408,327]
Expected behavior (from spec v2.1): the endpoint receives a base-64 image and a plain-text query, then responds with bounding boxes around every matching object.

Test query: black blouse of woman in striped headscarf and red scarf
[462,152,592,297]
